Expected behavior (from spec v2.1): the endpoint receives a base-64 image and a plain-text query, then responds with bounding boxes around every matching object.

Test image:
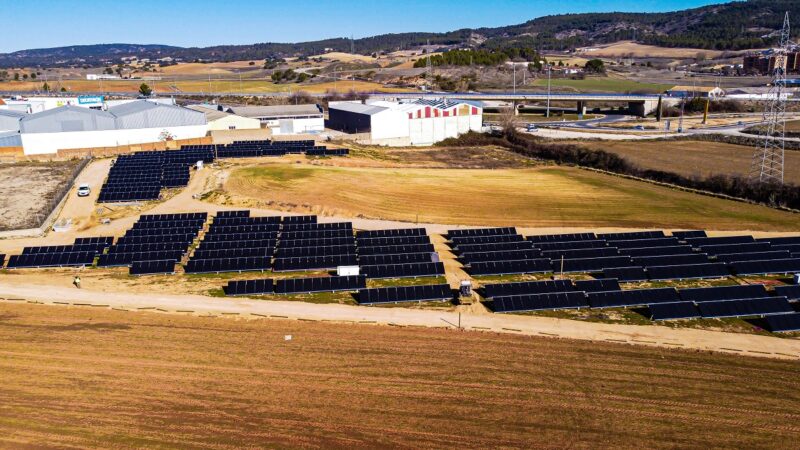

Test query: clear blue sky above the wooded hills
[0,0,720,52]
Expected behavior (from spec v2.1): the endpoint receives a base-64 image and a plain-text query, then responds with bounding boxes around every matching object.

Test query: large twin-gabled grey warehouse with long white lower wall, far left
[0,100,207,155]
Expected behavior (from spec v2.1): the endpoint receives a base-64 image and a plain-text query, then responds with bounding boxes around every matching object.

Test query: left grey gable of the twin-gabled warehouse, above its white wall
[19,106,116,133]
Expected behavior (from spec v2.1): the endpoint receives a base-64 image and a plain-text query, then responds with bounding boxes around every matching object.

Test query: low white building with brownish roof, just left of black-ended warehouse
[225,104,325,136]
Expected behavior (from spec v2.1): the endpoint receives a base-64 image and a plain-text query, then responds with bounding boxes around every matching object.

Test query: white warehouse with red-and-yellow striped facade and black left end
[327,100,483,146]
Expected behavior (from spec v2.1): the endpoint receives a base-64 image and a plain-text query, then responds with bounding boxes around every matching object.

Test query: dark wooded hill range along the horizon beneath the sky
[0,0,800,67]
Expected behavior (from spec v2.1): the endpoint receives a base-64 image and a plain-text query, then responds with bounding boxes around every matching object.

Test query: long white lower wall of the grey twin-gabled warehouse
[21,125,208,155]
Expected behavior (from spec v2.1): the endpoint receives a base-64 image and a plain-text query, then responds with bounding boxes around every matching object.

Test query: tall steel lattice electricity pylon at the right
[750,11,791,184]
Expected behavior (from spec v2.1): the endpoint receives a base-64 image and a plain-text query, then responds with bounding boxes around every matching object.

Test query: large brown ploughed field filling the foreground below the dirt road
[0,303,800,449]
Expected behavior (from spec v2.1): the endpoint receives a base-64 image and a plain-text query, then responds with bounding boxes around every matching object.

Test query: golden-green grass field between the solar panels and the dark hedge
[220,163,800,231]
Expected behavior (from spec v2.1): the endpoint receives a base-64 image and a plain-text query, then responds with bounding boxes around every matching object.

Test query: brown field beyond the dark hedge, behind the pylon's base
[574,141,800,184]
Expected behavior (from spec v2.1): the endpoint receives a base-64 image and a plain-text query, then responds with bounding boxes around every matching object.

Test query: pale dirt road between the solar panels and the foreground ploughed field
[0,277,800,359]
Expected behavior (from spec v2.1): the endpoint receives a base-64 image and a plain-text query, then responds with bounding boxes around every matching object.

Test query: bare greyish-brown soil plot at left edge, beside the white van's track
[0,161,78,231]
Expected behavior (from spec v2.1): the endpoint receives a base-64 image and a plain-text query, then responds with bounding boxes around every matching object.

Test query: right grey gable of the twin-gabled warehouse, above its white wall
[108,101,206,130]
